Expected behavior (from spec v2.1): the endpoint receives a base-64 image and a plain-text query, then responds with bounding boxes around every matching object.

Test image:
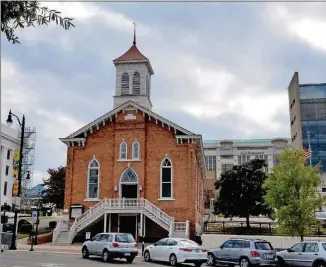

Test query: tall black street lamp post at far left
[7,110,25,250]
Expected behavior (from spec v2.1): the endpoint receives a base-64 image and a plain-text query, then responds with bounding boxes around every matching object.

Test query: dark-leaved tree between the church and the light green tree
[215,159,272,228]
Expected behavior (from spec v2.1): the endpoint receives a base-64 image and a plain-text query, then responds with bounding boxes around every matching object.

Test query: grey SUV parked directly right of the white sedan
[207,239,277,267]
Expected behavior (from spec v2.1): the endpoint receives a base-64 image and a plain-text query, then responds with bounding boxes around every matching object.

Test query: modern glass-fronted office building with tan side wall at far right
[288,72,326,192]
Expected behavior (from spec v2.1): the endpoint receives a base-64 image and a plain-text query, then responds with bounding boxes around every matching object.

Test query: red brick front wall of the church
[65,109,204,237]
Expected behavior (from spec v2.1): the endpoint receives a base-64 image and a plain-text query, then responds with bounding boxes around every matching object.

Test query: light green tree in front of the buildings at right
[264,150,325,241]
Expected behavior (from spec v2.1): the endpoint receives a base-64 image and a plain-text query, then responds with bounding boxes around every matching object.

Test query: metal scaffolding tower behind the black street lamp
[18,127,36,204]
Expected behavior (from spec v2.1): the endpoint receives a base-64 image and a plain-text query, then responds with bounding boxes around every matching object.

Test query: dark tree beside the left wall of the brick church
[42,166,66,209]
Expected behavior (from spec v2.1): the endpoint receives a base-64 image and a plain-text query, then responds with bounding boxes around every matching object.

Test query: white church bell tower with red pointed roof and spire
[113,24,154,110]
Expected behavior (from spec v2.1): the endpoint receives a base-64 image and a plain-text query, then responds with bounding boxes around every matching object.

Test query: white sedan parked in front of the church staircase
[144,238,207,267]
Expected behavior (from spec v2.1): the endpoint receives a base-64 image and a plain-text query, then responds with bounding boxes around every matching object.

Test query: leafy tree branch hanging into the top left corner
[1,1,75,44]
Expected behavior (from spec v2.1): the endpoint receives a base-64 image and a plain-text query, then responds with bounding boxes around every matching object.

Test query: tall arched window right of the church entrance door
[160,157,173,198]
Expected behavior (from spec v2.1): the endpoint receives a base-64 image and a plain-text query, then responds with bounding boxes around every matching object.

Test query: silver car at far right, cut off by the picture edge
[276,241,326,267]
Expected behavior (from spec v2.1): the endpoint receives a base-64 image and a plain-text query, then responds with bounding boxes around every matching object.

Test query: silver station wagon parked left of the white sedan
[82,233,138,263]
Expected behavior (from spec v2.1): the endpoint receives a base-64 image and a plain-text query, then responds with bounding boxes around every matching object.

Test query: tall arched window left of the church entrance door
[87,158,100,199]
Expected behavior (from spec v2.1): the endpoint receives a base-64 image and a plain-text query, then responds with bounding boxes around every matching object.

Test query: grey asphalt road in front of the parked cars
[1,251,197,267]
